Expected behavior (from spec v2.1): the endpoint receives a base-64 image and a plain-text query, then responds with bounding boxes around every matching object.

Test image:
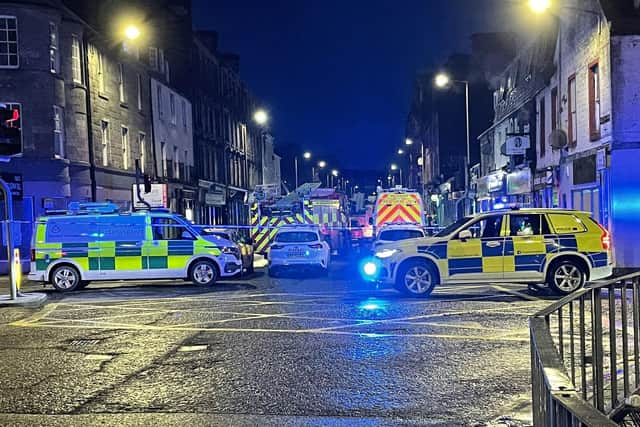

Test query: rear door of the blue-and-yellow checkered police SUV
[504,213,555,281]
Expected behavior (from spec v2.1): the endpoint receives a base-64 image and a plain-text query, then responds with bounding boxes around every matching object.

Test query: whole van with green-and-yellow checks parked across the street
[29,203,242,291]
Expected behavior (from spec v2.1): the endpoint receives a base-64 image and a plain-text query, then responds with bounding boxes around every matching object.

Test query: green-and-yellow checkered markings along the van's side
[34,216,232,275]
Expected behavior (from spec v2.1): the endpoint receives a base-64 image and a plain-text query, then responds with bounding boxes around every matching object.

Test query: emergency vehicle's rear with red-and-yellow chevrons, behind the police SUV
[373,188,425,234]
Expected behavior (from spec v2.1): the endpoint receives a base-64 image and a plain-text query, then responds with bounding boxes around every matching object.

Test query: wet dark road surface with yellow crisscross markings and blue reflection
[0,262,554,426]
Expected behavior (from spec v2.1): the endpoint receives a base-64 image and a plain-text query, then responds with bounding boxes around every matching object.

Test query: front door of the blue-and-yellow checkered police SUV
[447,214,505,281]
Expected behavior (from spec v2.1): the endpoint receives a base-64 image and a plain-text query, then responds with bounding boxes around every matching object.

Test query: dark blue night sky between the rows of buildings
[193,0,509,168]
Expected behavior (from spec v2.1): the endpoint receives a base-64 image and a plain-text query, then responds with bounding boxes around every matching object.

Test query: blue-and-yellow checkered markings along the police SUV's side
[417,214,609,278]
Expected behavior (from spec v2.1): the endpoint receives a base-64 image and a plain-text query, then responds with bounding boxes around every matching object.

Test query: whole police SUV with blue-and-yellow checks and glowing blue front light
[362,209,612,296]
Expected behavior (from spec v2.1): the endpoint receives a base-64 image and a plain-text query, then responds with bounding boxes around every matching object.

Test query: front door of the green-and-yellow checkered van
[144,217,196,278]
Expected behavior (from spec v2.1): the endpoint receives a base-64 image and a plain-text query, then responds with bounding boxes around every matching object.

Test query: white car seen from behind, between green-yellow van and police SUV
[267,225,331,277]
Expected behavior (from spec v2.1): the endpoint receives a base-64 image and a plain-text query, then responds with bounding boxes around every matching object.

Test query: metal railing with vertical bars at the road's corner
[529,272,640,427]
